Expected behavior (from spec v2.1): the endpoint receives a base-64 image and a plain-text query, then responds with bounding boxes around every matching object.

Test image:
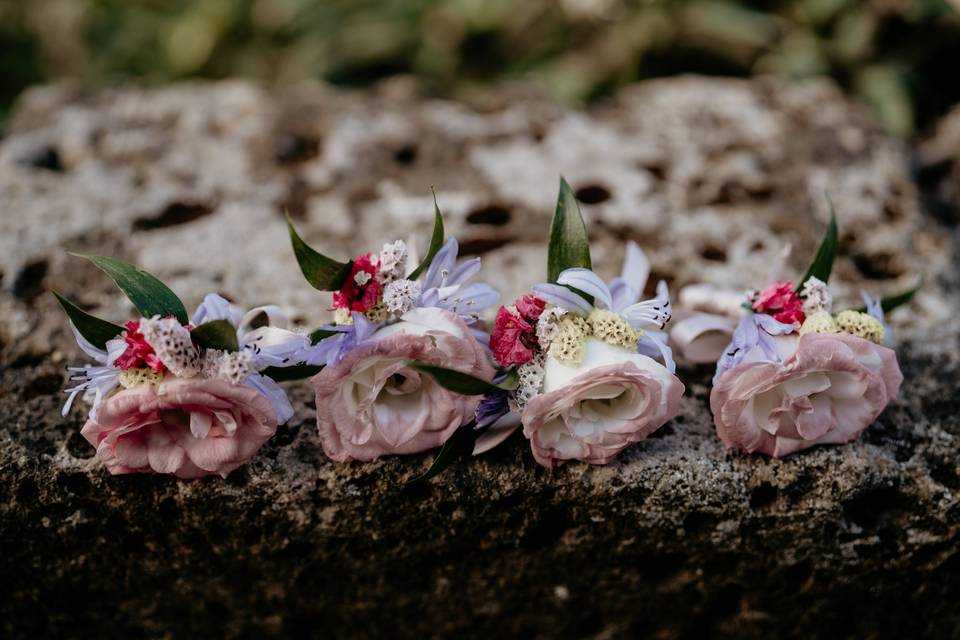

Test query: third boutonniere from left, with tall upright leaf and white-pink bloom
[408,179,684,473]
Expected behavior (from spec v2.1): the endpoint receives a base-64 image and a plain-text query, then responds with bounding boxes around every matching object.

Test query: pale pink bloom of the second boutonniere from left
[310,308,495,462]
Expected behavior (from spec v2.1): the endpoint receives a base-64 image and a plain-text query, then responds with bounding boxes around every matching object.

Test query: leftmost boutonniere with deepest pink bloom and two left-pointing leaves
[54,256,309,478]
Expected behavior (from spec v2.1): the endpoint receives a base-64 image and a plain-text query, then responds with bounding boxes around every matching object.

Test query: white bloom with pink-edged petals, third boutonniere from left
[522,338,684,467]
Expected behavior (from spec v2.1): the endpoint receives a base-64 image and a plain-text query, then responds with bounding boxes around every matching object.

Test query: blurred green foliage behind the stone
[0,0,960,135]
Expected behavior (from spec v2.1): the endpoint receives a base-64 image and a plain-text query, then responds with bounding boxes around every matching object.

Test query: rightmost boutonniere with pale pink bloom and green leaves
[690,202,919,458]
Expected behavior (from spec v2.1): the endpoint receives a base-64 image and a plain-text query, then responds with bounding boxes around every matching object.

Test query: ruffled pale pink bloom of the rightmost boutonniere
[710,333,903,458]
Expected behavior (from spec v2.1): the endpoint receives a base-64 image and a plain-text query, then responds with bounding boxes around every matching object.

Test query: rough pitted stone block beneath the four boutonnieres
[0,78,960,638]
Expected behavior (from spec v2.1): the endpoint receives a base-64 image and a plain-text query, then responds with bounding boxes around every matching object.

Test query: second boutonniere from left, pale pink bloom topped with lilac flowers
[289,192,499,462]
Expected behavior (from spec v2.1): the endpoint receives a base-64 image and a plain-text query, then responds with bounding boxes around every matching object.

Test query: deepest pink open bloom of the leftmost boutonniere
[80,378,277,478]
